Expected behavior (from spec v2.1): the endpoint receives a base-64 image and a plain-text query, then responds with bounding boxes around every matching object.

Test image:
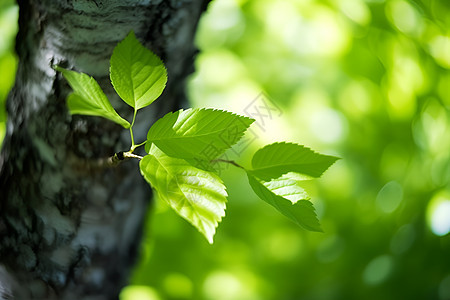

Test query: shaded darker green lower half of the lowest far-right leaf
[247,173,323,232]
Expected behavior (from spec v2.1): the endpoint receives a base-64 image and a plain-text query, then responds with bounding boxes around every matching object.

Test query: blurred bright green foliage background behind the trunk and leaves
[0,0,450,300]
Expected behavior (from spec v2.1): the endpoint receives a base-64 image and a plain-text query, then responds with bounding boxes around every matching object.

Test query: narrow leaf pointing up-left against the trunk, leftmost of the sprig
[55,67,130,128]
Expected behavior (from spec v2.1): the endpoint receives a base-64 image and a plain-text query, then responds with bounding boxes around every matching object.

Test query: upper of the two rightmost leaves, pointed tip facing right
[250,143,338,181]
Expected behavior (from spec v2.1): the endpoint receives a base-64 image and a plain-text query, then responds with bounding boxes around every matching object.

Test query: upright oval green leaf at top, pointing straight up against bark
[110,31,167,110]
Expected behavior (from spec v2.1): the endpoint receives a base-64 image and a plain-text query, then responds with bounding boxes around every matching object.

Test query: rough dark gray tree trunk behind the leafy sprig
[0,0,207,300]
